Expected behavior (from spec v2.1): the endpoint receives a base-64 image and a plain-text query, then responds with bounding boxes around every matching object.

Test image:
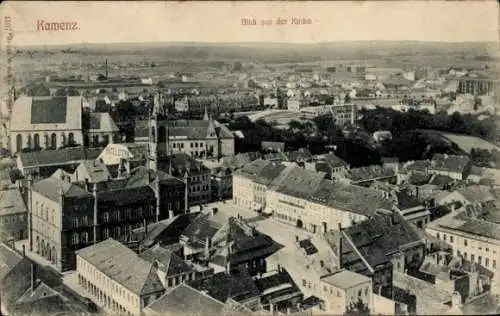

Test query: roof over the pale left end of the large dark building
[33,177,92,202]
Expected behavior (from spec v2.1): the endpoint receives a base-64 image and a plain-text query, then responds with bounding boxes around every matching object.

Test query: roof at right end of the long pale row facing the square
[309,180,393,216]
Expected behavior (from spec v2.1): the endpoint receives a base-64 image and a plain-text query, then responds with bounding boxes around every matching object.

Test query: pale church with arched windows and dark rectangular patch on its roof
[9,96,83,153]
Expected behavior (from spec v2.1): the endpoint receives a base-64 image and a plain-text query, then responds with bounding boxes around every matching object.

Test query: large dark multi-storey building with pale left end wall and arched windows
[28,163,186,271]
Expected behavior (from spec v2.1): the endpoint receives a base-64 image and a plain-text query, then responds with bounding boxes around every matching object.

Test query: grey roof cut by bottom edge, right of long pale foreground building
[145,284,224,315]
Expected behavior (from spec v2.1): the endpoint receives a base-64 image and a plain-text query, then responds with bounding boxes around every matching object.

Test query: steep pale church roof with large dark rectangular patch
[11,96,82,131]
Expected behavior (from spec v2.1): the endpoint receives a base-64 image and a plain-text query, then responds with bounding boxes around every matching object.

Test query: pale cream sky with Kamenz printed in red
[0,0,499,46]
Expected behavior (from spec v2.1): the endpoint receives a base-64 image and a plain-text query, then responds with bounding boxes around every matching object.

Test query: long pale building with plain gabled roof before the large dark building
[76,238,165,315]
